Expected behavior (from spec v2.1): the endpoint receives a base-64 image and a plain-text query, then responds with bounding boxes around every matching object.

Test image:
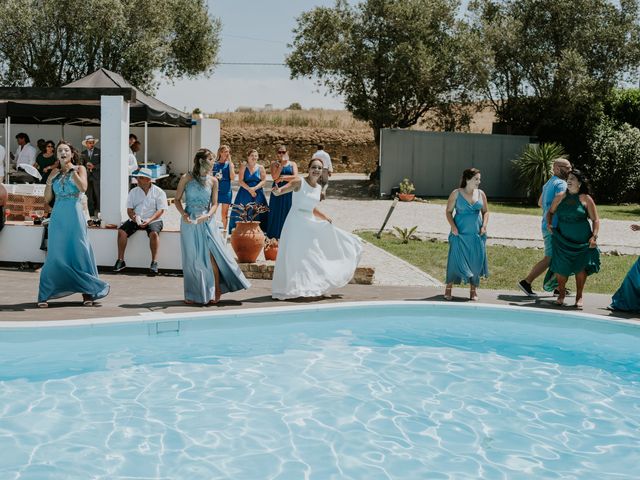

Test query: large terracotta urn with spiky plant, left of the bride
[231,202,269,263]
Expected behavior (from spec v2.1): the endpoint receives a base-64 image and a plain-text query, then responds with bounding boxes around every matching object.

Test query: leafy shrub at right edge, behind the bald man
[587,118,640,203]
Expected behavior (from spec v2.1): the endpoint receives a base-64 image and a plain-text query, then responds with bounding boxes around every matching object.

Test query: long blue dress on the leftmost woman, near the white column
[38,173,109,302]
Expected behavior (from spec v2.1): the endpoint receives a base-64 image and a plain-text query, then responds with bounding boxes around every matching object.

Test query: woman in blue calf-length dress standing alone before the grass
[444,168,489,300]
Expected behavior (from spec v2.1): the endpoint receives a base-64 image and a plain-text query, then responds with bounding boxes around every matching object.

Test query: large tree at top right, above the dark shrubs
[469,0,640,160]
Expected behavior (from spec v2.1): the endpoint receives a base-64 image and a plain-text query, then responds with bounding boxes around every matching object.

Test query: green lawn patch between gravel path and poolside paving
[359,232,636,294]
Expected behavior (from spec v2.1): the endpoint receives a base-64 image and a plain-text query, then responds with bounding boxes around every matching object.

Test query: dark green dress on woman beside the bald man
[544,192,600,292]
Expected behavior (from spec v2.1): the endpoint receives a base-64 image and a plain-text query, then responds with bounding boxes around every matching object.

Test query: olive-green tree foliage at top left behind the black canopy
[0,0,221,92]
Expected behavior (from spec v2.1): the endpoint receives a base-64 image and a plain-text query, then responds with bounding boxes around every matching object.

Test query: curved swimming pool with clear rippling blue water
[0,302,640,479]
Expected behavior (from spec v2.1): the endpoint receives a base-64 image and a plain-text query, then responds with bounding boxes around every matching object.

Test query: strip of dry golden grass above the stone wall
[211,108,371,132]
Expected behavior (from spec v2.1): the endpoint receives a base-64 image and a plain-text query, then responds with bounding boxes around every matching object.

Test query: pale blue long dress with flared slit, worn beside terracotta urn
[180,177,251,305]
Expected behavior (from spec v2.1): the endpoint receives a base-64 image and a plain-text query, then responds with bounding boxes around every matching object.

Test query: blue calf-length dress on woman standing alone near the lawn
[447,193,489,286]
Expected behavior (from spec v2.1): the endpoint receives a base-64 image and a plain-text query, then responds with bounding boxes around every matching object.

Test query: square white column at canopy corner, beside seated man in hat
[100,96,129,225]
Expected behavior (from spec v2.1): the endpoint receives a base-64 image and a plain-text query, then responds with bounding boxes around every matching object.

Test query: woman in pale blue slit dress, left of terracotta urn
[175,149,251,305]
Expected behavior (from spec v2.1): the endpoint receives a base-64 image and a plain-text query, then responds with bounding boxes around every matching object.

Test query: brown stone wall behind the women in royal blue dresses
[221,125,379,174]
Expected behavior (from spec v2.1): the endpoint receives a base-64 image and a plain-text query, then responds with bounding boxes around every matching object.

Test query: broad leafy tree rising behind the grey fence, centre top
[286,0,477,142]
